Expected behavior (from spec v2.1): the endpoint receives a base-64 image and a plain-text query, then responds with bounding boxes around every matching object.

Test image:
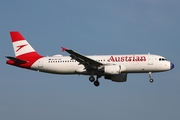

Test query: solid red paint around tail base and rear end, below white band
[6,52,43,69]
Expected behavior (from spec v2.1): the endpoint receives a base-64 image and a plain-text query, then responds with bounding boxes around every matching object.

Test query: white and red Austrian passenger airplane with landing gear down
[6,31,174,86]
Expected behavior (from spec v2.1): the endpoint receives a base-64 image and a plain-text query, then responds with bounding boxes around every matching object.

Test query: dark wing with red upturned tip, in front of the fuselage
[62,47,103,69]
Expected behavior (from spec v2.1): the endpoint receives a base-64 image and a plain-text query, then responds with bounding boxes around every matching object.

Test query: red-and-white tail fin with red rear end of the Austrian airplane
[7,31,43,68]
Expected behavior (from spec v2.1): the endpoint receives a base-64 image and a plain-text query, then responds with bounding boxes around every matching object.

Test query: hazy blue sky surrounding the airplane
[0,0,180,120]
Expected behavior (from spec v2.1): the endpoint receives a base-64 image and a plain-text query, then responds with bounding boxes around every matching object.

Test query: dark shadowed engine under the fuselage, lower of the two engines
[104,73,127,82]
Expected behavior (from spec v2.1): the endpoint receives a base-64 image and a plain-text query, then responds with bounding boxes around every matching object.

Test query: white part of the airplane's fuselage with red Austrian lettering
[31,54,171,74]
